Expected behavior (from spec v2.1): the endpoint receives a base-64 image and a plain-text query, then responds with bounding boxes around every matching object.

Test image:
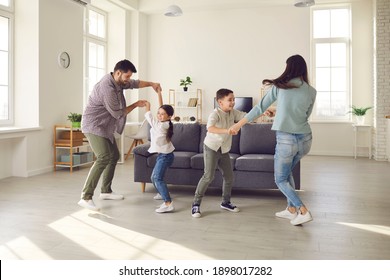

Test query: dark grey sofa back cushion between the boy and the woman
[240,123,276,155]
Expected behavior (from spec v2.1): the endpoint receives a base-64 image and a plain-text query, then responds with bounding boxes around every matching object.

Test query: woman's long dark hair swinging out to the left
[263,54,309,89]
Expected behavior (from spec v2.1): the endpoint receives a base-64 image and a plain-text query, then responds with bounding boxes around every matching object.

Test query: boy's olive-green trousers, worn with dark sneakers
[193,145,234,205]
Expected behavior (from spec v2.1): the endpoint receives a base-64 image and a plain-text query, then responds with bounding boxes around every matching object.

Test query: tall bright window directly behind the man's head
[85,7,107,101]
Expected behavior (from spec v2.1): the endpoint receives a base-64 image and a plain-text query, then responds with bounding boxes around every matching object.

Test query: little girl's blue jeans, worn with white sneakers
[150,153,175,202]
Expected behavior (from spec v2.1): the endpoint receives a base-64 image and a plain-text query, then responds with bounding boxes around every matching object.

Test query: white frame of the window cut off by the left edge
[0,3,15,126]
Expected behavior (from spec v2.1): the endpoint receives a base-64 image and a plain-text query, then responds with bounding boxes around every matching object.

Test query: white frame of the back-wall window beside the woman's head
[310,4,352,123]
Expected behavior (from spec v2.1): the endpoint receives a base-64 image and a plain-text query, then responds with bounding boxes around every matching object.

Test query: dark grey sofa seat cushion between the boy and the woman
[235,154,274,172]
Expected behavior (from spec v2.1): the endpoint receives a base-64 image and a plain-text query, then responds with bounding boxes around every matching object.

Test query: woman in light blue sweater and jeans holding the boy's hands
[232,55,317,226]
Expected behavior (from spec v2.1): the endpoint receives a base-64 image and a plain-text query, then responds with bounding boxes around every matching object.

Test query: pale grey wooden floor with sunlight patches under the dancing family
[0,156,390,260]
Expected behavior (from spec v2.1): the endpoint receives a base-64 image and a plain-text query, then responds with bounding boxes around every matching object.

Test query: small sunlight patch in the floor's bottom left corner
[0,236,52,260]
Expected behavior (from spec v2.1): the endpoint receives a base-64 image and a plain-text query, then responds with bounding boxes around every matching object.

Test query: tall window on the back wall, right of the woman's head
[312,7,351,121]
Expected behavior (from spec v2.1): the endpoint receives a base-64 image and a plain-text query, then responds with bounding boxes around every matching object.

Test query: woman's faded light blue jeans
[274,131,312,209]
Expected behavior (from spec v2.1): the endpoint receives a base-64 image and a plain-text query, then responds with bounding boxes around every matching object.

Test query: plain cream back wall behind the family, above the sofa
[147,6,310,116]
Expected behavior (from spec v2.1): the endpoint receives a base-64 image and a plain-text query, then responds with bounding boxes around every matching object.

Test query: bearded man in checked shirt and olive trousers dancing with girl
[78,60,161,211]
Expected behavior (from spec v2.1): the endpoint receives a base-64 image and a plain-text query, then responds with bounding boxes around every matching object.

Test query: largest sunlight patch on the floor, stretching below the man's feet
[49,210,211,260]
